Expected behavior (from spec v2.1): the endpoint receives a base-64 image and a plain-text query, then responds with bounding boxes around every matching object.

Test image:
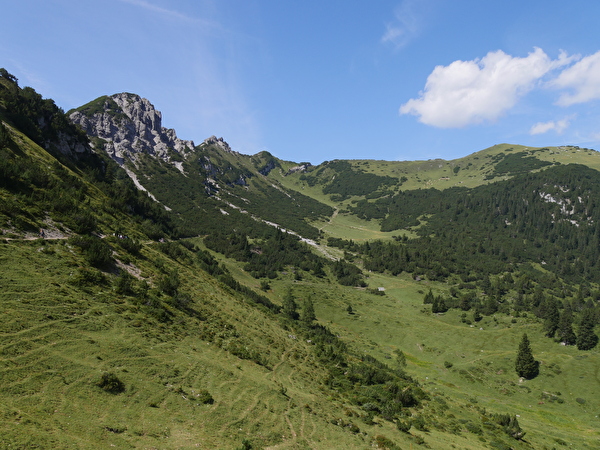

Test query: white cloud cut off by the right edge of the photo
[549,51,600,106]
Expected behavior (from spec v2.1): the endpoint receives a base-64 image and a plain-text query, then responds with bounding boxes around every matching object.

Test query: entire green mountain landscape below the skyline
[0,69,600,450]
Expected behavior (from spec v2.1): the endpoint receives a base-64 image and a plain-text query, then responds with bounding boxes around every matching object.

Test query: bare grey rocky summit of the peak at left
[69,93,194,165]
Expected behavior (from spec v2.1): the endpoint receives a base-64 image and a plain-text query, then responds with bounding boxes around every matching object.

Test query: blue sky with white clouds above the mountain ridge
[0,0,600,164]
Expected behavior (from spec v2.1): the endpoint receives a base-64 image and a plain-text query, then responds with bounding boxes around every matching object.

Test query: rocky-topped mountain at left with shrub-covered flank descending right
[69,94,332,239]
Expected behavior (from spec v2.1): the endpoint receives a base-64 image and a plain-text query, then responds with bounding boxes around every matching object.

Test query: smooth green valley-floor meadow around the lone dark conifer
[262,268,600,449]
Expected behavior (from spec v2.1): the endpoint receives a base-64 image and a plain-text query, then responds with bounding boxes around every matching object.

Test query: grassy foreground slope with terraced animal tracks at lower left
[0,240,384,448]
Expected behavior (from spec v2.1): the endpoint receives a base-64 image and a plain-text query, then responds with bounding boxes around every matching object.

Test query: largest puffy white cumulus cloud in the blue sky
[400,48,572,128]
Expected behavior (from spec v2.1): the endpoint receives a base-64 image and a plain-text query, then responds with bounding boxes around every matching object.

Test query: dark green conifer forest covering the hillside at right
[328,164,600,349]
